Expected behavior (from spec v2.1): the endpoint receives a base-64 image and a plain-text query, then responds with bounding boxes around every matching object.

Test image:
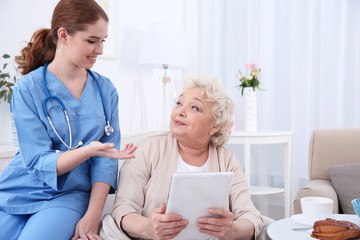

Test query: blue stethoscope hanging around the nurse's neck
[42,62,114,151]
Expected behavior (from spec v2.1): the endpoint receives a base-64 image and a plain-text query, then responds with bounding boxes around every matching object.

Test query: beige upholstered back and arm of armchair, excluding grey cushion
[294,128,360,214]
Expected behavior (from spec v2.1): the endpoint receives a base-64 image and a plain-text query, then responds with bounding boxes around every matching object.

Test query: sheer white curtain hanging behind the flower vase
[198,0,360,218]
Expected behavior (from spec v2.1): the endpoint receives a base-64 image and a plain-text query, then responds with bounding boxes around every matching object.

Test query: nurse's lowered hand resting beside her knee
[72,214,104,240]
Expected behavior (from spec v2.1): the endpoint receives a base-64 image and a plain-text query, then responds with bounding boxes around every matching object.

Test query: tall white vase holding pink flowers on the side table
[243,87,257,131]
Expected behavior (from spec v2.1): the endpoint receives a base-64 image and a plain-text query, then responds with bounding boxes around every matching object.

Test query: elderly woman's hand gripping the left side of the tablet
[147,204,188,240]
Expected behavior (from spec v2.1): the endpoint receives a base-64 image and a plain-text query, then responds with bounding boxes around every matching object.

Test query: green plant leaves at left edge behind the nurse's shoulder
[0,54,20,103]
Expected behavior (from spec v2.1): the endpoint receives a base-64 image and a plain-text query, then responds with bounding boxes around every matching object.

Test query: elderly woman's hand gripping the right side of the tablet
[196,208,233,239]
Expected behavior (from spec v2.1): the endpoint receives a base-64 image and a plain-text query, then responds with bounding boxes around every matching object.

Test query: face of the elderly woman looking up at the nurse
[170,87,218,143]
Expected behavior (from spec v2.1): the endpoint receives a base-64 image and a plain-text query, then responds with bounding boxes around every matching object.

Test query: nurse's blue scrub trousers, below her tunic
[0,207,82,240]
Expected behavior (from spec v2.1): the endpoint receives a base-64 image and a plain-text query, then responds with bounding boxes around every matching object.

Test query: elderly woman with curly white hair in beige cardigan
[101,76,263,240]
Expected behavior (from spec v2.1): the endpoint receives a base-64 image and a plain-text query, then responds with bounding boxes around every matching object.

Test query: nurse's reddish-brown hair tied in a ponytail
[15,0,109,75]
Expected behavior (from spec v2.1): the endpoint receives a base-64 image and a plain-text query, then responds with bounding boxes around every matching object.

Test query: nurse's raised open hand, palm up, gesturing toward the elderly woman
[85,141,137,159]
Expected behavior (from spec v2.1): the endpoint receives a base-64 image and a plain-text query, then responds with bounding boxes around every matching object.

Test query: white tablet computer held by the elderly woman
[166,172,234,240]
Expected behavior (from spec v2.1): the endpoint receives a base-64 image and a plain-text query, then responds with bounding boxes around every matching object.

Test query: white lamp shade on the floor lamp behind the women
[139,23,188,69]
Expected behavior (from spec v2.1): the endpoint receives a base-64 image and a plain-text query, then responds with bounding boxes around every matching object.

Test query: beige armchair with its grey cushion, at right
[293,128,360,214]
